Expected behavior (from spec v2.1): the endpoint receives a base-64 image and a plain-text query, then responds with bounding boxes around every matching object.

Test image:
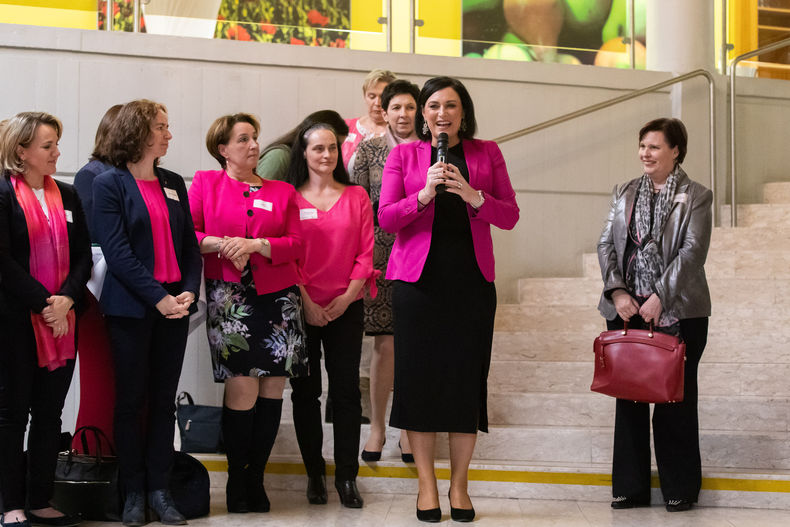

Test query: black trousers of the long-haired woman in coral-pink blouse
[291,300,364,481]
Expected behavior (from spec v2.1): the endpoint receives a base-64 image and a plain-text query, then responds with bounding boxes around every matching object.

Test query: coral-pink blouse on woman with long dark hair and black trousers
[297,185,380,307]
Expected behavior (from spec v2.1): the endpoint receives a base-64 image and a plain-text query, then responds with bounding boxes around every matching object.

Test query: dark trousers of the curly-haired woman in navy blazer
[106,311,189,493]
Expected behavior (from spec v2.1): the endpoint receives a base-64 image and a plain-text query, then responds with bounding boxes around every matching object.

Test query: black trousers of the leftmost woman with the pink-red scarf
[0,313,74,511]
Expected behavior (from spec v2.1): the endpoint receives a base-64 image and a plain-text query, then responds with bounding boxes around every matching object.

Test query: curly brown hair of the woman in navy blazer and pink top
[106,99,167,167]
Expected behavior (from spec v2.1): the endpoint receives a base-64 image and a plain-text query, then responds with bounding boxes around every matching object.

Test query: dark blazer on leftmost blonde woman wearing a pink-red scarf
[0,172,93,318]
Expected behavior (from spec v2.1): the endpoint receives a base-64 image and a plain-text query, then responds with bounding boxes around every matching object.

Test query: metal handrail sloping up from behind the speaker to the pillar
[494,69,717,224]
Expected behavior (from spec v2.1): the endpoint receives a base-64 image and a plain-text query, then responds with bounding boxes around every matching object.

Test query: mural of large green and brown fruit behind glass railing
[463,0,647,69]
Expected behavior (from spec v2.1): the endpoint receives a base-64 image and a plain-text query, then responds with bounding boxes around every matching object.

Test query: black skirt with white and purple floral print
[206,279,309,382]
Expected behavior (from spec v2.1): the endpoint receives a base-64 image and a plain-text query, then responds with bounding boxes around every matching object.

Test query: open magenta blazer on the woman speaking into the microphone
[378,139,519,282]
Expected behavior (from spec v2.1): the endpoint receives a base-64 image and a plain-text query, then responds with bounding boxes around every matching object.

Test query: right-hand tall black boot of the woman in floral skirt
[246,397,283,512]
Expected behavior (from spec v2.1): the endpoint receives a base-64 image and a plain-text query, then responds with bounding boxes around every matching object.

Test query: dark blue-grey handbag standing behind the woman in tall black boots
[176,392,224,453]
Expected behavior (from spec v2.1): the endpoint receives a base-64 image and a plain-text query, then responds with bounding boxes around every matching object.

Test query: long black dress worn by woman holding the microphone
[390,143,496,433]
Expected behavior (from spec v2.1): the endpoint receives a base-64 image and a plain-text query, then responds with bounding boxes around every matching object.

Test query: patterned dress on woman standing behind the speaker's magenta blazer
[351,136,395,335]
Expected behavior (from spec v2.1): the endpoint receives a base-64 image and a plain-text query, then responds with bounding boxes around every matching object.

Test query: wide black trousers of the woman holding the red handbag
[607,316,708,502]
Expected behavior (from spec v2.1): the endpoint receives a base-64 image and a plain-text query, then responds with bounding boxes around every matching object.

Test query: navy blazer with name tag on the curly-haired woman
[92,167,203,318]
